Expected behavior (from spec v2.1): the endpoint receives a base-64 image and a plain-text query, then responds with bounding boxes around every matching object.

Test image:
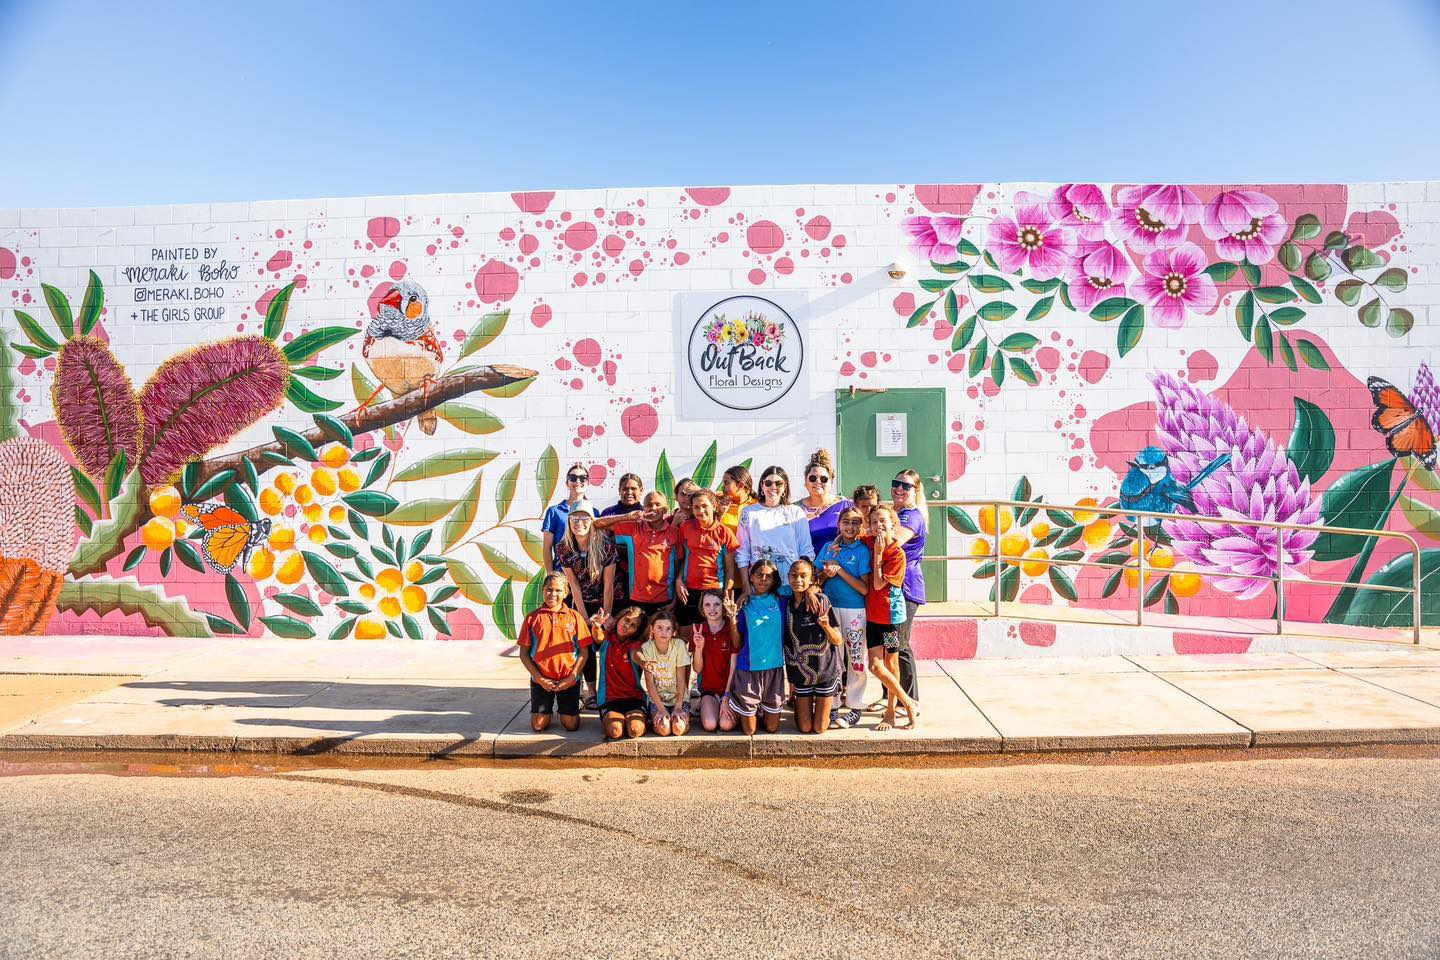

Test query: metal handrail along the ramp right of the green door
[926,498,1421,643]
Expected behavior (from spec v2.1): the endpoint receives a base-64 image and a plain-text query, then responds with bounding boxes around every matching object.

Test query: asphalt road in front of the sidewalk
[0,757,1440,960]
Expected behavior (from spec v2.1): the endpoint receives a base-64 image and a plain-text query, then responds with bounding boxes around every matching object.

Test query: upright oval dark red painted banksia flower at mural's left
[50,337,140,479]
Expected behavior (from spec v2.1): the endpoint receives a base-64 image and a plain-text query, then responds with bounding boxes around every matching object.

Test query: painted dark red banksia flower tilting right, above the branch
[140,337,289,485]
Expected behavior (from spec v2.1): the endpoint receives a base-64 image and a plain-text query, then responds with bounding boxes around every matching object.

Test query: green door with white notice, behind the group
[835,387,946,602]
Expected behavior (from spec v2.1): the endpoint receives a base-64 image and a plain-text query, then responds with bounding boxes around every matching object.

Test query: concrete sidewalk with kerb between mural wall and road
[0,638,1440,757]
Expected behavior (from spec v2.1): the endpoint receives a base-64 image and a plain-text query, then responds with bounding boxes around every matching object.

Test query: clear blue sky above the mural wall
[0,0,1440,206]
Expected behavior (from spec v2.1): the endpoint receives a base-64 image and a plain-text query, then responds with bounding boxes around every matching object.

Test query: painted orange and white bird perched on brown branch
[360,281,445,433]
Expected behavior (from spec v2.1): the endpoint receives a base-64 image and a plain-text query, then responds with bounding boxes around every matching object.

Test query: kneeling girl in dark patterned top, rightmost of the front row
[785,557,845,734]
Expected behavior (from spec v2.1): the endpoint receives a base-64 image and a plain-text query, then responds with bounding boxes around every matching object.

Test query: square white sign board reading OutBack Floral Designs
[675,292,811,420]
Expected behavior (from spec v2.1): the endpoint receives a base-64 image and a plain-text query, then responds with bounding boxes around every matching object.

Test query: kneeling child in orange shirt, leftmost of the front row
[517,573,590,733]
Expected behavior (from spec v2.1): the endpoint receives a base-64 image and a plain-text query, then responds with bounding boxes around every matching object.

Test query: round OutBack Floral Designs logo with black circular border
[687,296,805,410]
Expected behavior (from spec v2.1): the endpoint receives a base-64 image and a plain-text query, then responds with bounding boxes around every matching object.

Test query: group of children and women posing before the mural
[518,449,926,740]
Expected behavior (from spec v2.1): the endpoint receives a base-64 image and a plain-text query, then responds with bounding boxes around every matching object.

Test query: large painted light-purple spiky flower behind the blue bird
[1153,374,1320,600]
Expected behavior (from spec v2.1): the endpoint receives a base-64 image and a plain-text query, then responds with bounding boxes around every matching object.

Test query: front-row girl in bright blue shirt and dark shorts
[730,555,785,737]
